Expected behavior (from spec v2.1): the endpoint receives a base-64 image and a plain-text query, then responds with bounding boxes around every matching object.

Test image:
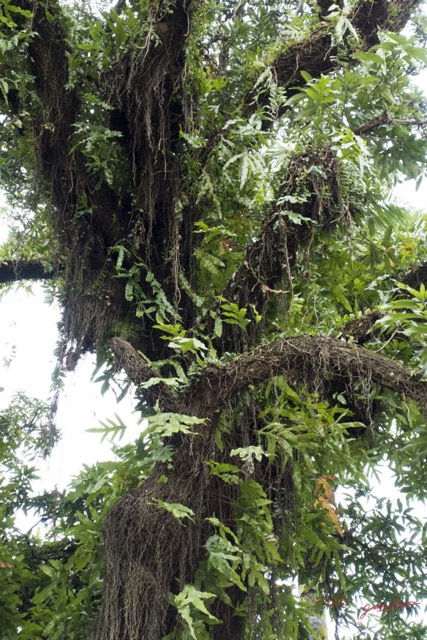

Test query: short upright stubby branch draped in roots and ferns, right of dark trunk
[214,145,350,352]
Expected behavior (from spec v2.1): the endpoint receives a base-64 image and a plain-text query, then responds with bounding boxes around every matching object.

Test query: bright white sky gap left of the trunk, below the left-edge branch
[0,284,141,490]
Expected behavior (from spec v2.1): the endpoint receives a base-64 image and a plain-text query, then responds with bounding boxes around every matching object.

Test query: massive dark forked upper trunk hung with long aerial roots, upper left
[7,0,199,359]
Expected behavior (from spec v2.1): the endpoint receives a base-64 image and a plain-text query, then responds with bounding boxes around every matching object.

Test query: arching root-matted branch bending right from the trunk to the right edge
[187,335,427,416]
